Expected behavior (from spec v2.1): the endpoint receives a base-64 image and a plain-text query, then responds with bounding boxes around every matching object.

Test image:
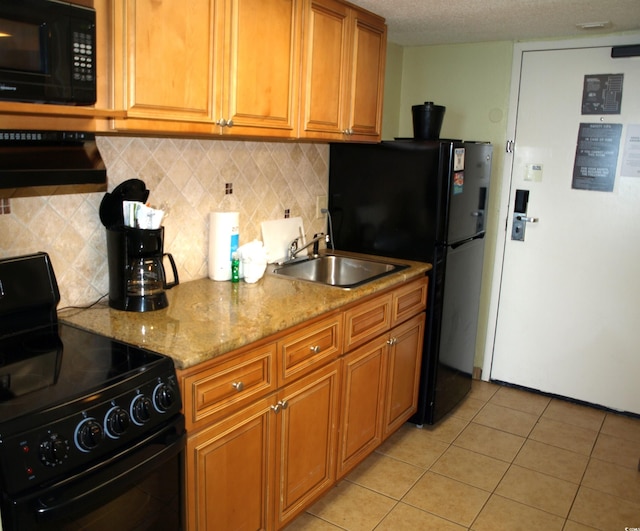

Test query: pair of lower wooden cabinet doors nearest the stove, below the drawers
[186,360,339,530]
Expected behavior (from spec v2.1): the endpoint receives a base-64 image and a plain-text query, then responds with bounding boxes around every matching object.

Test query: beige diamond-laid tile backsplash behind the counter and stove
[0,136,329,308]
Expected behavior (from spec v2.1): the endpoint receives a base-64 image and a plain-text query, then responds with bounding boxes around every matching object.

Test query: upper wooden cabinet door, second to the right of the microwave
[214,0,302,138]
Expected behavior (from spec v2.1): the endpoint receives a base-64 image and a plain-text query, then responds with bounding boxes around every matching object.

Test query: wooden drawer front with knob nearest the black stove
[182,343,276,429]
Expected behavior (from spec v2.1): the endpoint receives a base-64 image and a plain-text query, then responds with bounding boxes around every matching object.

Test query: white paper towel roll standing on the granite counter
[209,212,240,280]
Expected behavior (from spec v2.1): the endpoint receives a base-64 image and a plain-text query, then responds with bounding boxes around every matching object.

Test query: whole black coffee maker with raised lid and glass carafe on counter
[100,179,179,312]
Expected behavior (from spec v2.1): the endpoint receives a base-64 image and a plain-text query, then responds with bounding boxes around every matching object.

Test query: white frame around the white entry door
[482,31,640,381]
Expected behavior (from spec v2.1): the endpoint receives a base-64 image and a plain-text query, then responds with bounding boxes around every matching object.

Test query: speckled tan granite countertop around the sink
[59,253,431,369]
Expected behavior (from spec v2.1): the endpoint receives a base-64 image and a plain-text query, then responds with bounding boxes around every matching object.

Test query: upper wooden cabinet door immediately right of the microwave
[114,0,218,128]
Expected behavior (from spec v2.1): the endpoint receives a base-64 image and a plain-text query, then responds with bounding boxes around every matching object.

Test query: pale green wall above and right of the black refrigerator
[382,42,513,367]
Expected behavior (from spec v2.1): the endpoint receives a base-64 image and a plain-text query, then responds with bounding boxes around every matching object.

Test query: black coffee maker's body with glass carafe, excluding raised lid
[107,226,179,312]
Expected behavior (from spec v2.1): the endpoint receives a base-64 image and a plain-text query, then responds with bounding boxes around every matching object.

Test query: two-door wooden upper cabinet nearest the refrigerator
[300,0,387,142]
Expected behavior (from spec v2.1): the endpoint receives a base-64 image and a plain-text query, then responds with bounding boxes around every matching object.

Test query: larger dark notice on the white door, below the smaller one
[571,123,622,192]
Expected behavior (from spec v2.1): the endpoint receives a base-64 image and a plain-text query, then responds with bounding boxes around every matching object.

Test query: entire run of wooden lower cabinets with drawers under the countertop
[179,277,428,531]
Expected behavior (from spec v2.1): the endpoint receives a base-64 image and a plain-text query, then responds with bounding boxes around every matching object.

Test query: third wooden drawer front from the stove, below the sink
[344,293,391,352]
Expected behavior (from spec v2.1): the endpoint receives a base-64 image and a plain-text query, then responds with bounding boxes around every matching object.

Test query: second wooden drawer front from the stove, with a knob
[278,315,342,385]
